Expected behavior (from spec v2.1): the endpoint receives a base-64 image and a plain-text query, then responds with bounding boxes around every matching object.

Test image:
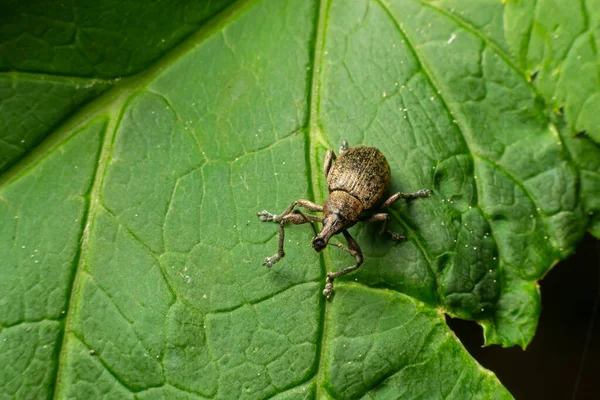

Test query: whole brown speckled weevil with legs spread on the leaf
[257,140,431,298]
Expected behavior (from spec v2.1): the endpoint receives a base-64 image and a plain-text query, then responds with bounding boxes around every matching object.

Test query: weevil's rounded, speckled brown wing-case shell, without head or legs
[327,146,391,210]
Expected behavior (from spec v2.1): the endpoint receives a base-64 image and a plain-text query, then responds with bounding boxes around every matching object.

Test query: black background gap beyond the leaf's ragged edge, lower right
[447,235,600,400]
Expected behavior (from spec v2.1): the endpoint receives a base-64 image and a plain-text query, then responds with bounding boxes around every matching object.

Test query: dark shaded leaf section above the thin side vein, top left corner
[0,0,233,78]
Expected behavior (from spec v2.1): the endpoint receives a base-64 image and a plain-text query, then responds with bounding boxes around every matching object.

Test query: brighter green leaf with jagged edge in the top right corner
[430,0,600,143]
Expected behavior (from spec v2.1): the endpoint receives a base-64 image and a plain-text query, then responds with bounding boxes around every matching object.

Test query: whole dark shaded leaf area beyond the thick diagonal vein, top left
[0,0,238,172]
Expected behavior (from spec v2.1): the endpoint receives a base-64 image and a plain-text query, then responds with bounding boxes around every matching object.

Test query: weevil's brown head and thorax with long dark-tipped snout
[311,190,363,252]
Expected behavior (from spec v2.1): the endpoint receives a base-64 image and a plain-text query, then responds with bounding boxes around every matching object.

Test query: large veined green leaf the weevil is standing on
[0,0,600,399]
